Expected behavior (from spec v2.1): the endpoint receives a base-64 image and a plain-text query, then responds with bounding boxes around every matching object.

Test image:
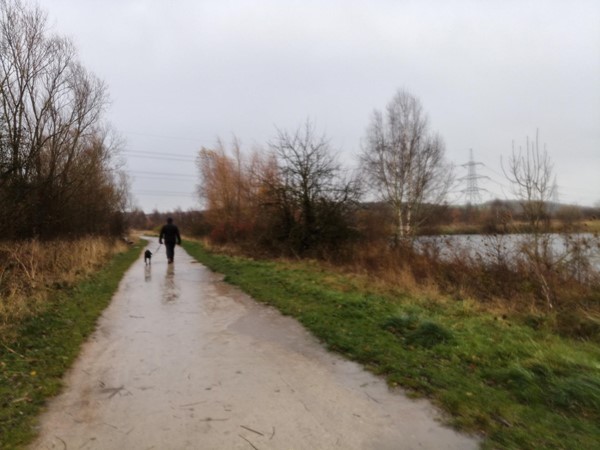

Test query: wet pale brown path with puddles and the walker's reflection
[33,237,477,450]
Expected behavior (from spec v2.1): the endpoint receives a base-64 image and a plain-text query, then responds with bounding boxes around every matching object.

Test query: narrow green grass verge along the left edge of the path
[0,243,143,449]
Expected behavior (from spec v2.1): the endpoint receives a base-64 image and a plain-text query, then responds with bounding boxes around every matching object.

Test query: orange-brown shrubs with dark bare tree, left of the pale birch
[198,122,359,256]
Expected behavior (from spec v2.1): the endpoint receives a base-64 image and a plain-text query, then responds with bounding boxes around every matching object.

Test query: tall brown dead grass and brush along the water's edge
[337,238,600,339]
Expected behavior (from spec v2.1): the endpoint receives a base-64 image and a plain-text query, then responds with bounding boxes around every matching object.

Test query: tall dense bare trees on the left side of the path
[0,0,127,239]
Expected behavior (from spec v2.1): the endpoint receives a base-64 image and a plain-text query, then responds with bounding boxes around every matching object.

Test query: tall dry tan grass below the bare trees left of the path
[0,237,126,336]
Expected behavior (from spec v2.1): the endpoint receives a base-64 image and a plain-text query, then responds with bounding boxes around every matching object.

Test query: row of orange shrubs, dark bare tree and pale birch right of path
[190,90,452,258]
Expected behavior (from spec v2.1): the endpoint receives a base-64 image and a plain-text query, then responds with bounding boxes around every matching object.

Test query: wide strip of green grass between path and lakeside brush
[184,241,600,450]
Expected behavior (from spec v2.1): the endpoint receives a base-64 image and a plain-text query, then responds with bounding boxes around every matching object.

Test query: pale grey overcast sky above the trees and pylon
[39,0,600,212]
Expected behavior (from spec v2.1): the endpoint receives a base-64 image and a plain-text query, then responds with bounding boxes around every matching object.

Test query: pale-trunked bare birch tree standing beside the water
[361,90,453,241]
